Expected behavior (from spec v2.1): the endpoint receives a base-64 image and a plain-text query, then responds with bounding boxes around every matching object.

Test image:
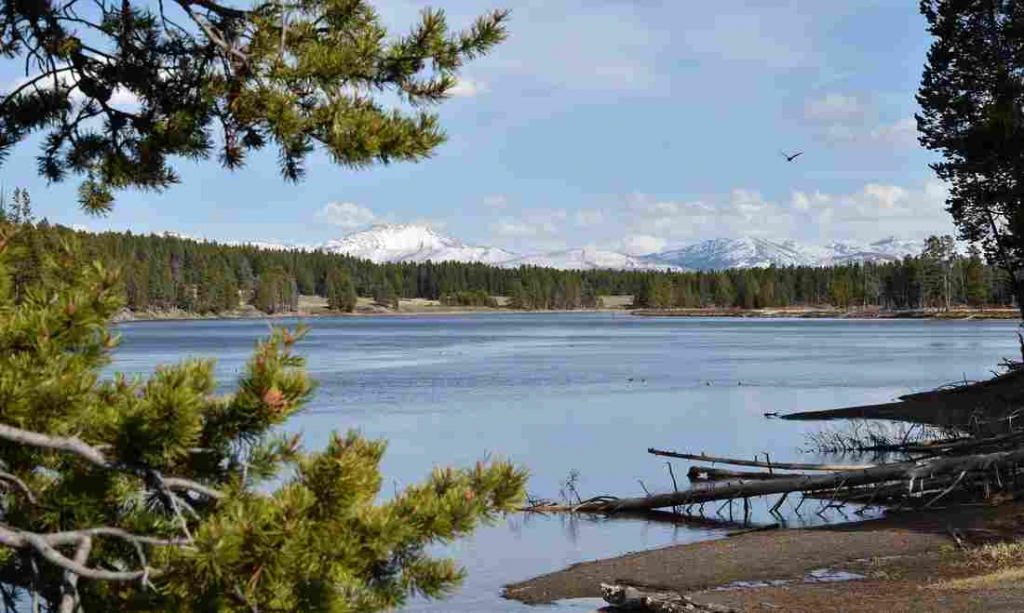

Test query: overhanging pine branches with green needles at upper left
[0,0,509,213]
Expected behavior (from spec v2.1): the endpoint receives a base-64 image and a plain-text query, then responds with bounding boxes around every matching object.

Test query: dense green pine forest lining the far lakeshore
[0,196,1013,313]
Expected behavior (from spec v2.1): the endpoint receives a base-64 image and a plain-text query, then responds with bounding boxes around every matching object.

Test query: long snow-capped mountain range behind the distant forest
[228,224,923,270]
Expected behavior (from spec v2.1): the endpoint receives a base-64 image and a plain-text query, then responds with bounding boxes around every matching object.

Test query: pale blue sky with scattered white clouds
[0,0,953,254]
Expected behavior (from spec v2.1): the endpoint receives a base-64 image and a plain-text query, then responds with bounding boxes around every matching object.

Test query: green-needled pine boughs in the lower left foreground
[0,232,526,613]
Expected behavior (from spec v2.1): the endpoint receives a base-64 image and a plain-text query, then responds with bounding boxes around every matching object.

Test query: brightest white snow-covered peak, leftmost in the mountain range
[323,224,519,264]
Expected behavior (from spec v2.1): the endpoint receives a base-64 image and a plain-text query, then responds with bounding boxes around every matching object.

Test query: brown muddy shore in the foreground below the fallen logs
[502,503,1024,613]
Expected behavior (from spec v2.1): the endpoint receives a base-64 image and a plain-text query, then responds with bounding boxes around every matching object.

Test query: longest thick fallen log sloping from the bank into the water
[575,448,1024,514]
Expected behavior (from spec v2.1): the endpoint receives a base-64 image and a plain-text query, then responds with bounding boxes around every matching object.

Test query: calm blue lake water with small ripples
[108,313,1018,612]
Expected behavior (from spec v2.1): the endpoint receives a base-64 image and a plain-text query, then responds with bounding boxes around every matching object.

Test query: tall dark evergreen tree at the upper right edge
[916,0,1024,313]
